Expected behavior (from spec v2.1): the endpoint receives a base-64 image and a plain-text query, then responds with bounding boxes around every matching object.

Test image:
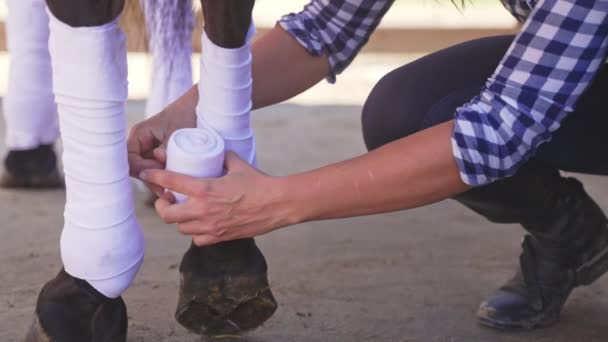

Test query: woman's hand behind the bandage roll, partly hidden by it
[127,85,198,187]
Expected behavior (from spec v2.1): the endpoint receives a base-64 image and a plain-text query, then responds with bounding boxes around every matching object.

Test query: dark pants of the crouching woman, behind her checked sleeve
[362,36,608,174]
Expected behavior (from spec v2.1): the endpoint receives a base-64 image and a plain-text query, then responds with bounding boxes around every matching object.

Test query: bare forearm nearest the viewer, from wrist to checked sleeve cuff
[279,121,468,223]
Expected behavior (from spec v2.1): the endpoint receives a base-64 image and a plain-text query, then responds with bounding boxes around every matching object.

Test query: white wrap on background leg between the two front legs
[141,0,194,117]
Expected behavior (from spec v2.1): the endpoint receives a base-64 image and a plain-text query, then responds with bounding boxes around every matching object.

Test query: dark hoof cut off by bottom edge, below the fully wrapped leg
[23,269,127,342]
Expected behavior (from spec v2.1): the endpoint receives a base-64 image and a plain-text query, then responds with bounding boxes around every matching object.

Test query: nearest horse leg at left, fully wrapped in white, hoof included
[26,0,143,342]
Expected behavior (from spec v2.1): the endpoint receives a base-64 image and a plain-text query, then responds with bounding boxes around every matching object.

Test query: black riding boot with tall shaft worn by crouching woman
[455,161,608,329]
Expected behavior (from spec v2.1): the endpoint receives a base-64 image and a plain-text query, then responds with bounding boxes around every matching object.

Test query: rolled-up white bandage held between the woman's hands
[166,128,224,202]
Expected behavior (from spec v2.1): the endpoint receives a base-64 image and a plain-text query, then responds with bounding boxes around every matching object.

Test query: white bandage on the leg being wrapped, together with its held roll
[167,22,257,202]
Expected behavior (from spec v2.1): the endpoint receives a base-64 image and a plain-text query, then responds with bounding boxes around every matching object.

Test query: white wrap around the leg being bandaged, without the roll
[196,20,257,165]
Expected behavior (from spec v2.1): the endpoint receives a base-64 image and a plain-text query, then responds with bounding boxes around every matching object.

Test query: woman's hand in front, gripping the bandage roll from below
[140,152,295,246]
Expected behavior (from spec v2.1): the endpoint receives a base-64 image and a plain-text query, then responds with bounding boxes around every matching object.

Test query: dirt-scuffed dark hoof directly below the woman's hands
[175,239,277,337]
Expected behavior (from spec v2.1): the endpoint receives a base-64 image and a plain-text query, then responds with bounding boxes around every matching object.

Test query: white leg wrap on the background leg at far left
[4,0,59,150]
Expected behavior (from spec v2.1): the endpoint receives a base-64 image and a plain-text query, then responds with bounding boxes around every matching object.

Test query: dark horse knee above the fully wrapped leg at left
[46,0,125,27]
